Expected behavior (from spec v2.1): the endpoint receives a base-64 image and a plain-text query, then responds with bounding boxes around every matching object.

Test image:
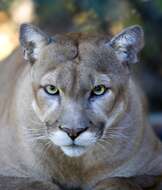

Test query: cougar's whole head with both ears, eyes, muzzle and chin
[20,24,142,157]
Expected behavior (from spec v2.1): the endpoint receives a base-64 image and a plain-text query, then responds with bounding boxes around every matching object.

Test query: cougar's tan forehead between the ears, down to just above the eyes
[36,34,127,87]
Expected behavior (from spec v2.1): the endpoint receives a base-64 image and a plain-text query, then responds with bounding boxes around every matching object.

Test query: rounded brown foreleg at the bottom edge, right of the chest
[92,178,142,190]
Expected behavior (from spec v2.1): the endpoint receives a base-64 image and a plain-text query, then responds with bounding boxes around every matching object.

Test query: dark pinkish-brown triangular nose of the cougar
[59,126,88,141]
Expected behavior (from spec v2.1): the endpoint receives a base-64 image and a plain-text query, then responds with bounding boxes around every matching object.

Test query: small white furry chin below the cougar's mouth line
[61,144,87,157]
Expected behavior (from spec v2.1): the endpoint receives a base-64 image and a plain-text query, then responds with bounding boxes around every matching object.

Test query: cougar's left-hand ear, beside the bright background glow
[20,24,51,64]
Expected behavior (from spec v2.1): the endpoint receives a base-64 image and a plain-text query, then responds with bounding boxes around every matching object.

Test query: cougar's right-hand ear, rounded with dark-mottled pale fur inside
[109,25,144,63]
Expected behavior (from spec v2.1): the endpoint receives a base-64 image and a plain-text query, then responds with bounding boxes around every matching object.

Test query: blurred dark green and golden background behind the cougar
[0,0,162,132]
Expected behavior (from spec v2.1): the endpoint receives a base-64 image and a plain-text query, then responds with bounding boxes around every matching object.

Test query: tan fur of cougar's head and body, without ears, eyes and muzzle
[0,24,162,190]
